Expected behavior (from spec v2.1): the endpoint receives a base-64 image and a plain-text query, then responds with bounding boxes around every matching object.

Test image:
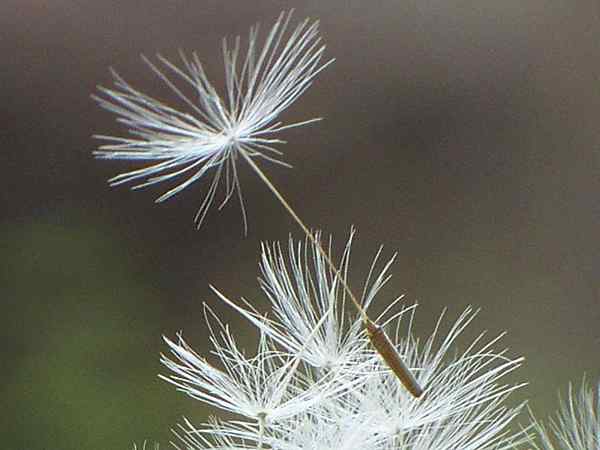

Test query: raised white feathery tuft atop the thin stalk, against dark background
[93,11,333,230]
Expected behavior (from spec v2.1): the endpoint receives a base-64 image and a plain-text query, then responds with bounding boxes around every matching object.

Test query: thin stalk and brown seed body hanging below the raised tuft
[239,150,423,397]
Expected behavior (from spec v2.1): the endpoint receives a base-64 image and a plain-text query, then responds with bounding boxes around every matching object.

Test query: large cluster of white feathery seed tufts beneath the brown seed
[163,236,527,450]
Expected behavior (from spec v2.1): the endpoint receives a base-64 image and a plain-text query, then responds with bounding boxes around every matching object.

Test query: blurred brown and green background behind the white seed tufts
[0,0,600,450]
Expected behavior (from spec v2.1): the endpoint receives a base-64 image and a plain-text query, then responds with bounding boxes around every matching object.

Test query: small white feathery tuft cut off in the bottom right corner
[533,379,600,450]
